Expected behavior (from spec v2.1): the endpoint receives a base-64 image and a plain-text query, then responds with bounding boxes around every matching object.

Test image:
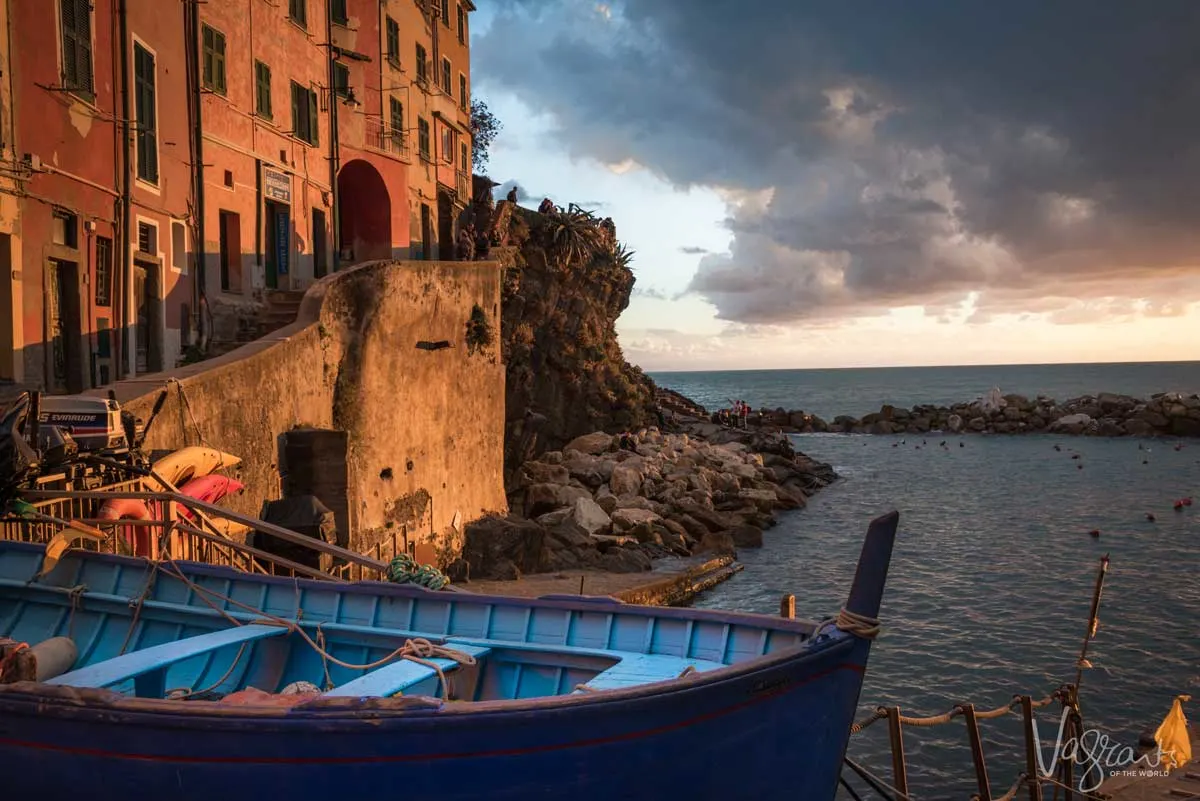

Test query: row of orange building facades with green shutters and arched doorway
[0,0,474,395]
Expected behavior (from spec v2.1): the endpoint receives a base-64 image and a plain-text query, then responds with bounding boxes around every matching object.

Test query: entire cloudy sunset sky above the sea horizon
[472,0,1200,371]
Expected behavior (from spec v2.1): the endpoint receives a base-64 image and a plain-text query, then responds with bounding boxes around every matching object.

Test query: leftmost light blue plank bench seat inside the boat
[46,624,288,698]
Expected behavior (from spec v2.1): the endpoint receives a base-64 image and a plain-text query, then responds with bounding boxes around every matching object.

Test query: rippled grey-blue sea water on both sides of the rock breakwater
[655,363,1200,800]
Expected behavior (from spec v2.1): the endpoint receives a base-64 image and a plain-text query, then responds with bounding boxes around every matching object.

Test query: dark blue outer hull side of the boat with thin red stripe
[0,639,868,801]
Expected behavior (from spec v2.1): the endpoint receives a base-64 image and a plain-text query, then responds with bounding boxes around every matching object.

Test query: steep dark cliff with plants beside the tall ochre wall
[496,204,658,483]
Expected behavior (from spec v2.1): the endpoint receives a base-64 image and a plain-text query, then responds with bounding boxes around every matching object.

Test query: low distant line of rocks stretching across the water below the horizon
[749,392,1200,436]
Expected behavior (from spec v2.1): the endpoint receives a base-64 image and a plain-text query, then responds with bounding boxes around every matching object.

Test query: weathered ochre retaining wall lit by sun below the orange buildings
[112,261,506,564]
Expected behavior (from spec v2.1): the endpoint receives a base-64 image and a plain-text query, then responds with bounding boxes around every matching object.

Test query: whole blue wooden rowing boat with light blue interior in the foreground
[0,512,898,801]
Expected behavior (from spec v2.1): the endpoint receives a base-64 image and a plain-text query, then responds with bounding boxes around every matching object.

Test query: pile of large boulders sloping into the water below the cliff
[449,427,836,582]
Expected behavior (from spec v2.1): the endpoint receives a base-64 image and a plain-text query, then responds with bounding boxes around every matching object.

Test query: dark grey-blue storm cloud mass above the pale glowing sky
[474,0,1200,324]
